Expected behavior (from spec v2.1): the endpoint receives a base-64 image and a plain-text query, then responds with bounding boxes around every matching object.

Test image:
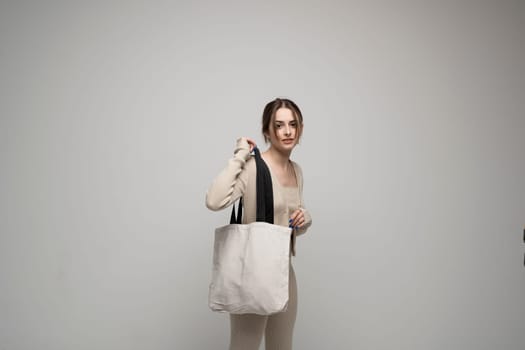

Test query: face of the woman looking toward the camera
[267,107,299,152]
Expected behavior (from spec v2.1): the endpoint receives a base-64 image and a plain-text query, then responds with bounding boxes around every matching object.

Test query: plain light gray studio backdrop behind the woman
[0,0,525,350]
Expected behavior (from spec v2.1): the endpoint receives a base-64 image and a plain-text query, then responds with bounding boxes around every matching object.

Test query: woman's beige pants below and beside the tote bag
[230,265,297,350]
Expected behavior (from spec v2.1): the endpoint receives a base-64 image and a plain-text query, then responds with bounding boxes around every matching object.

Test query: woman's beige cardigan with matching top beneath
[206,138,312,255]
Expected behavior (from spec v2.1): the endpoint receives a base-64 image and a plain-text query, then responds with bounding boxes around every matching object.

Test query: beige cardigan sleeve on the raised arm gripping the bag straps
[206,137,251,210]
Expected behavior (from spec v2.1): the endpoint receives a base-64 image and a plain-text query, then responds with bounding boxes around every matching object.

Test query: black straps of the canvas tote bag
[230,147,273,224]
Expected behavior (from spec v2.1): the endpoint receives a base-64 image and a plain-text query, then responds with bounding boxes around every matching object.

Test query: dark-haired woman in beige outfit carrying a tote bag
[206,98,312,350]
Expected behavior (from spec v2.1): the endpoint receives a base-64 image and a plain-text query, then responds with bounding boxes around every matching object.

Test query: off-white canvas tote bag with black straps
[209,148,291,315]
